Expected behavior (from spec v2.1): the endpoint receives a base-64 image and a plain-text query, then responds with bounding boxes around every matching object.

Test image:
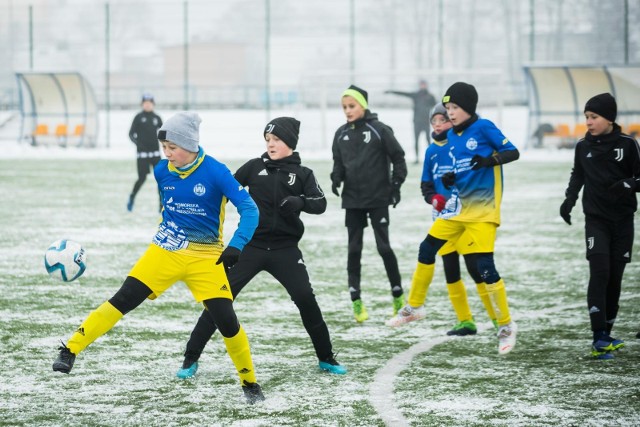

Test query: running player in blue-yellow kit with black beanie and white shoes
[390,82,520,354]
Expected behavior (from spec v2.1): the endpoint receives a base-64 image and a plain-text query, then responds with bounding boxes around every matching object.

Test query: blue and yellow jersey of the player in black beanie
[447,119,516,224]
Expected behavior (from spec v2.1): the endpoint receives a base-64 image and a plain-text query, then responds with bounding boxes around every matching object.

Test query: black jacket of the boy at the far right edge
[565,123,640,222]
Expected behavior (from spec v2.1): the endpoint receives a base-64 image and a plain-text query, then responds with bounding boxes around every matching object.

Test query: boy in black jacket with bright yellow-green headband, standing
[331,85,407,322]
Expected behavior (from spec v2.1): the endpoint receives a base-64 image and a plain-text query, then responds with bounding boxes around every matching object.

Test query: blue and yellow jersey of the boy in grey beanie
[153,149,257,257]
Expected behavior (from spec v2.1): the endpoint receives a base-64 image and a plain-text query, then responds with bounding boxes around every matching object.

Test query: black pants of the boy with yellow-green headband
[345,207,403,301]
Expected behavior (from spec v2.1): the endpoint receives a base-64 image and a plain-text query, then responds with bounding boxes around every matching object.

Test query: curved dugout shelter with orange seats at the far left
[16,72,98,147]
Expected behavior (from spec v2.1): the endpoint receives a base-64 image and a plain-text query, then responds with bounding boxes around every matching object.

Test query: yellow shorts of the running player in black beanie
[429,218,498,255]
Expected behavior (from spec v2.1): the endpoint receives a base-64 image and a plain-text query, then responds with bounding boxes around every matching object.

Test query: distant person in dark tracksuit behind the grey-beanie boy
[127,93,162,212]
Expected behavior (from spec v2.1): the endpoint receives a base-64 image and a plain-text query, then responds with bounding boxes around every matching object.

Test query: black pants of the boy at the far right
[585,216,634,334]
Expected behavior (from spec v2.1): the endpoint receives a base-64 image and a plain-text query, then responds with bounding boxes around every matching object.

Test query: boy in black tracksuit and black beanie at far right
[560,93,640,359]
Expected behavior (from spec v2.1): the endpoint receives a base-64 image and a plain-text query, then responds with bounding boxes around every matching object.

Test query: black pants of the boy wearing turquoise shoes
[184,245,333,361]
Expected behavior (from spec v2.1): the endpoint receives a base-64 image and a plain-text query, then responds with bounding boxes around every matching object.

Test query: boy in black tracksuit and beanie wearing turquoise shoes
[177,117,347,378]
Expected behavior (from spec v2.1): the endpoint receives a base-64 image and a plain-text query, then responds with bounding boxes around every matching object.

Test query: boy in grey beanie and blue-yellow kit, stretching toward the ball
[53,112,264,403]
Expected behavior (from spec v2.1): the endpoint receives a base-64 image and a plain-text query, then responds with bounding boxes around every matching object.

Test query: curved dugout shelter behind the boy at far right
[524,65,640,147]
